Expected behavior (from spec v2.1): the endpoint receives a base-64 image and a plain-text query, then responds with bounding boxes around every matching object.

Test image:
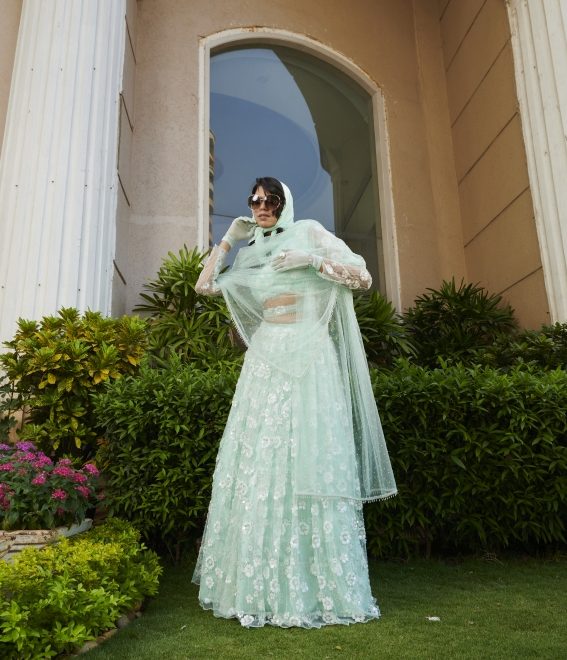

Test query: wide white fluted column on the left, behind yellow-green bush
[0,0,125,340]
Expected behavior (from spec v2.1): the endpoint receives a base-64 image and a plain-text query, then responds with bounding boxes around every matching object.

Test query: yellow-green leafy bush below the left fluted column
[0,309,146,458]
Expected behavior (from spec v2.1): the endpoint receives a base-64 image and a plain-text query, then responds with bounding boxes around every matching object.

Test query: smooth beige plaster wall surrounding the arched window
[126,0,465,307]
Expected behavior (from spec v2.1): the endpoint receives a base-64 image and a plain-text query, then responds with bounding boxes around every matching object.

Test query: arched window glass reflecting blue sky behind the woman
[209,45,385,292]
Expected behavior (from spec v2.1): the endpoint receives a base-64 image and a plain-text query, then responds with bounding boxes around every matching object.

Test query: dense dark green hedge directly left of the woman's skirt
[95,356,239,555]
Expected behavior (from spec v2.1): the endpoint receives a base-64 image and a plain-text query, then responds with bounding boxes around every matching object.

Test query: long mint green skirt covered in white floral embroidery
[193,324,380,628]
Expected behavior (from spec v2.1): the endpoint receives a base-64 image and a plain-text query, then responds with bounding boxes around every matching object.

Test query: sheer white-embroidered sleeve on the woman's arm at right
[311,223,372,290]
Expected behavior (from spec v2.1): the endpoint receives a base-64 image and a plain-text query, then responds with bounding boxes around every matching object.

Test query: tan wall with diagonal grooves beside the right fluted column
[439,0,549,327]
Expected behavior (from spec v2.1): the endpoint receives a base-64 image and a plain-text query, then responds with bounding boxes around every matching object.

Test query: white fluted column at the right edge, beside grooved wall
[508,0,567,321]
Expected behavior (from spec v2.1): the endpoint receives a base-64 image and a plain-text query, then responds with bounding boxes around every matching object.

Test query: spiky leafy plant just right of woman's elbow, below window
[354,291,415,367]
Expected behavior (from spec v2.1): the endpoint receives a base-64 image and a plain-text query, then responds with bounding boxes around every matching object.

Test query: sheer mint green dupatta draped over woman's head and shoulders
[217,184,396,501]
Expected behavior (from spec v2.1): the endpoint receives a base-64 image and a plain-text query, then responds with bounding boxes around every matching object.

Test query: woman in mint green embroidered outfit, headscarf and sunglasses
[193,177,396,628]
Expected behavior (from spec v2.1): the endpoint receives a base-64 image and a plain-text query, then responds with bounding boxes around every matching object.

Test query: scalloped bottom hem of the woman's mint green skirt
[199,599,380,628]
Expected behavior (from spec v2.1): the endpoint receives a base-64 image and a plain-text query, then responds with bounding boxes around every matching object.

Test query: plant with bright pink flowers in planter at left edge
[0,442,99,530]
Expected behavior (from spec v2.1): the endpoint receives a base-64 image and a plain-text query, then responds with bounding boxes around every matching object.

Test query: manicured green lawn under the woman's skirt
[88,559,567,660]
